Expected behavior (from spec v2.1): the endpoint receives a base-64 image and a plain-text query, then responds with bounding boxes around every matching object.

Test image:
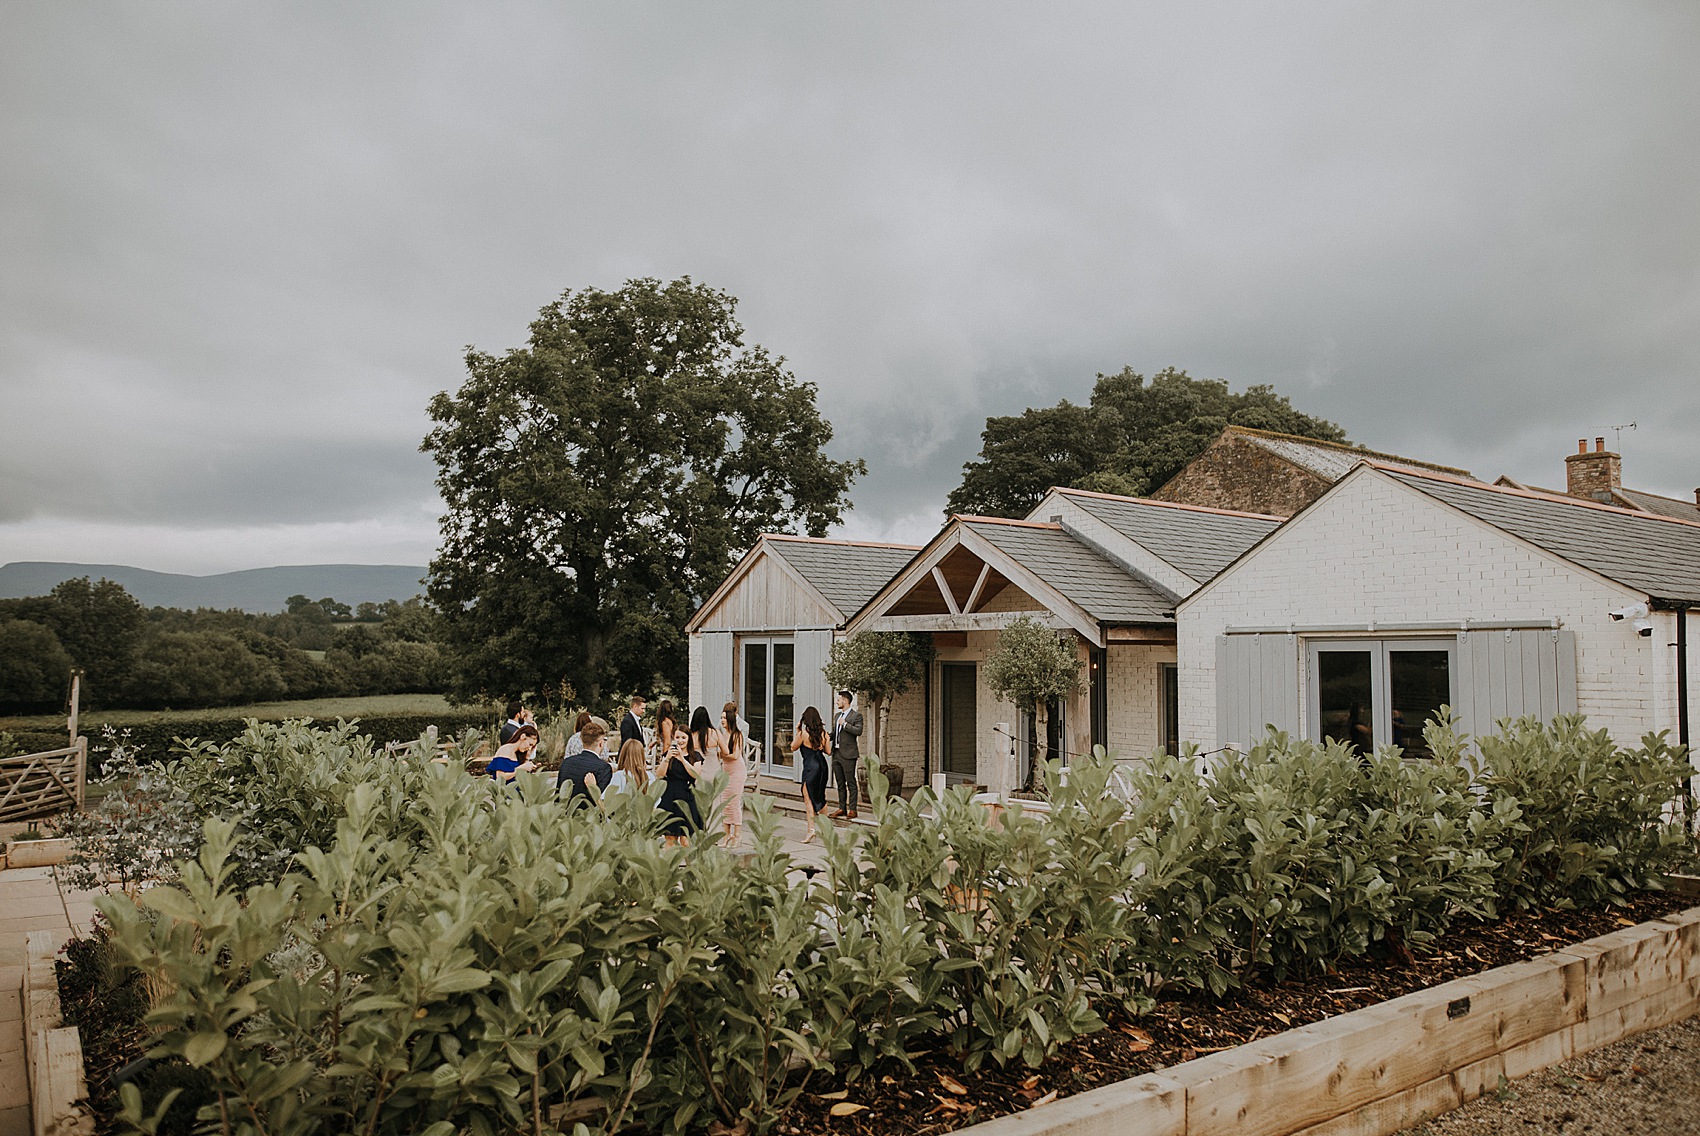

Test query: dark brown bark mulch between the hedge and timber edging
[779,893,1693,1136]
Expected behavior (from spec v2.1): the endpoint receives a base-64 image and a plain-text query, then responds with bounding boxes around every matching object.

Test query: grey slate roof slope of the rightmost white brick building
[1384,469,1700,604]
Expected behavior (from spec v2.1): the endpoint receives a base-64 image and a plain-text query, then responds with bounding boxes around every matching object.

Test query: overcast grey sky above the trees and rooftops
[0,0,1700,573]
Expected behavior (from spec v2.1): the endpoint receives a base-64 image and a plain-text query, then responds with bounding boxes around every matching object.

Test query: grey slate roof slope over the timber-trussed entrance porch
[962,517,1175,624]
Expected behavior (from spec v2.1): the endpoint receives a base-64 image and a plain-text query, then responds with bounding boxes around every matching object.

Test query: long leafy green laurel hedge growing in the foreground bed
[86,718,1683,1136]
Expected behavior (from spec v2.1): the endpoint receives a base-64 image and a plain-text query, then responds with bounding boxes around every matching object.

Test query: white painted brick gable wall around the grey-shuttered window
[1178,469,1675,748]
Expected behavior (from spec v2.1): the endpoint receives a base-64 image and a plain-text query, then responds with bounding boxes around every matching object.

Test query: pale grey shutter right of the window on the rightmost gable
[1457,628,1576,735]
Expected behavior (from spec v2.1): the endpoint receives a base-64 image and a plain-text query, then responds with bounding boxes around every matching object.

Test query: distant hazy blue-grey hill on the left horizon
[0,559,425,612]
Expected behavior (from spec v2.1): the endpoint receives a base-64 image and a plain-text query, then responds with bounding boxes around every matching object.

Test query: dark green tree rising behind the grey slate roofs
[947,367,1346,517]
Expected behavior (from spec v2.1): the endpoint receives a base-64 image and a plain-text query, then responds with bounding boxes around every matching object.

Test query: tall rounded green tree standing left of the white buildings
[422,277,865,704]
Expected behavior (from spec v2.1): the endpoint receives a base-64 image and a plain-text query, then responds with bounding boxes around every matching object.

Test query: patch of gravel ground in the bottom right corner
[1401,1017,1700,1136]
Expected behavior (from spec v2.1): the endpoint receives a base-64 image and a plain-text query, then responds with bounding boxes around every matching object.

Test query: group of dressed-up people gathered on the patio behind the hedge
[486,690,862,843]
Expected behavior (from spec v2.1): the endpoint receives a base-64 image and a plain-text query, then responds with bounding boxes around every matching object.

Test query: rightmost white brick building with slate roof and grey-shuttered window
[1176,463,1700,761]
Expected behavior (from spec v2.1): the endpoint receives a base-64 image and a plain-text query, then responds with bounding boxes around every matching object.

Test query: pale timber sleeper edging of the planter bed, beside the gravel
[962,908,1700,1136]
